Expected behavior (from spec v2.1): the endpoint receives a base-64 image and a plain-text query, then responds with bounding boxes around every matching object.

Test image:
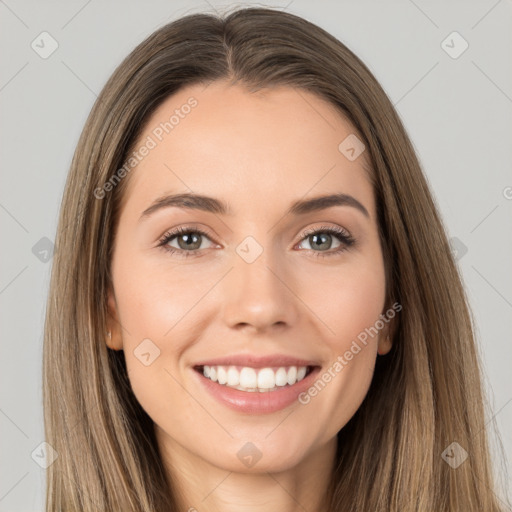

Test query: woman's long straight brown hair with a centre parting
[43,8,503,512]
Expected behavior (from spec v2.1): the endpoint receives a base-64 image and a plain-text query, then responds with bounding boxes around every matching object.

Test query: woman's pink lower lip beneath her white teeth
[192,367,320,414]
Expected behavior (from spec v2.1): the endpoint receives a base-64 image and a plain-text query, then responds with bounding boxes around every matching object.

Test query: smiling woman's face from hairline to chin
[107,82,390,472]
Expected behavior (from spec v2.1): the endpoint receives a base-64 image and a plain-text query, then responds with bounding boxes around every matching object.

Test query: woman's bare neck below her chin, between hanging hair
[156,428,337,512]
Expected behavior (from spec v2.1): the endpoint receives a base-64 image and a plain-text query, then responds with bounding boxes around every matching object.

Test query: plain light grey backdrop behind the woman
[0,0,512,511]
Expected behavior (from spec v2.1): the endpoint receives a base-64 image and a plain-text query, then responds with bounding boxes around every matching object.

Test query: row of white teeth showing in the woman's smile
[203,366,307,392]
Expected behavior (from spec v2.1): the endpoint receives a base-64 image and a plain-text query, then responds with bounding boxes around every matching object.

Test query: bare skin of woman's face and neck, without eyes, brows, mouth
[107,82,391,512]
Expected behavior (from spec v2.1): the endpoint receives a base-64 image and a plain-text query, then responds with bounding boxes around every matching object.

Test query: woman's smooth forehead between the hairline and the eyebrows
[123,82,374,221]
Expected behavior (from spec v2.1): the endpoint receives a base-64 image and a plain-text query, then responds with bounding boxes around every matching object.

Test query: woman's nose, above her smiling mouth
[221,242,300,332]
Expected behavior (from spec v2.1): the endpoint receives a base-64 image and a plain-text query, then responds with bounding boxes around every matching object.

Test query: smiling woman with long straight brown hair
[44,8,501,512]
